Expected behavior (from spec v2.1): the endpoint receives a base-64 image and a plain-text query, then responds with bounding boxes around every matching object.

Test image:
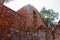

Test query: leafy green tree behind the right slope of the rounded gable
[40,7,58,28]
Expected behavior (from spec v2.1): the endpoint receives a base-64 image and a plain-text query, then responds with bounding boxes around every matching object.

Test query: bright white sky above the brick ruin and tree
[4,0,60,20]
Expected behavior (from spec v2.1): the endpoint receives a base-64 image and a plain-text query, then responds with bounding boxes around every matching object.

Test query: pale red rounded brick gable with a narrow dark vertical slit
[17,5,46,28]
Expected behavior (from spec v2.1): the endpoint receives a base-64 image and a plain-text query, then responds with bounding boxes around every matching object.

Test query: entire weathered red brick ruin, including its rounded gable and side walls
[0,5,60,40]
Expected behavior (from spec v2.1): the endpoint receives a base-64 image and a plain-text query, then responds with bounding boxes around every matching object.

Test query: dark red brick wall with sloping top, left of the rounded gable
[0,5,25,40]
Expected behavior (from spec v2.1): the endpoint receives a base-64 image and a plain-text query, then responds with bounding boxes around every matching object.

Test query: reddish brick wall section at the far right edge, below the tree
[53,21,60,40]
